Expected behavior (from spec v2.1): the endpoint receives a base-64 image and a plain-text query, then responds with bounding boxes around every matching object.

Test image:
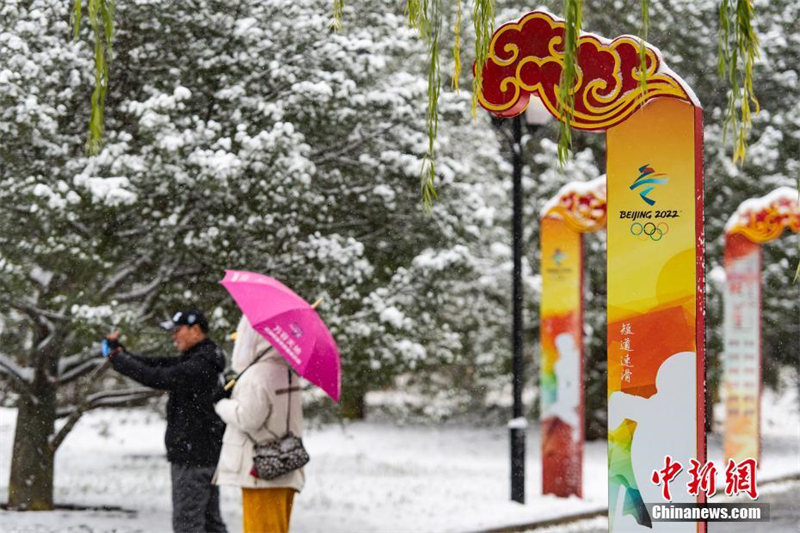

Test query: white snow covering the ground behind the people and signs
[0,380,800,533]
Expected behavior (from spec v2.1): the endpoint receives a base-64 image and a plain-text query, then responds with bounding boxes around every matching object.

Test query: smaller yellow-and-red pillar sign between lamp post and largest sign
[539,177,606,497]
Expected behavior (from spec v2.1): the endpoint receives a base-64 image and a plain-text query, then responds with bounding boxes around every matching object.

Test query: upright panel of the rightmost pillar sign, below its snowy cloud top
[722,234,761,461]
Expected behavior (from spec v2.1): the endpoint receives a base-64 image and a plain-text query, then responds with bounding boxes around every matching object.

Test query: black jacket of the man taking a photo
[111,339,225,466]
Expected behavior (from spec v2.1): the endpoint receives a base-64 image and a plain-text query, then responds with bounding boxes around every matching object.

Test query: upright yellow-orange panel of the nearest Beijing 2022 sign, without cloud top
[607,98,705,533]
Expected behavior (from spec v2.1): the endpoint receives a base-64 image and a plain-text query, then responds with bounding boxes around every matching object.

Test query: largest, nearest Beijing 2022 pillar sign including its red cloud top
[480,11,706,533]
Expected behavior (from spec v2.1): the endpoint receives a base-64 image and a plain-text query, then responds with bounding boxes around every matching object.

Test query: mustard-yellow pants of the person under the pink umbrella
[242,488,295,533]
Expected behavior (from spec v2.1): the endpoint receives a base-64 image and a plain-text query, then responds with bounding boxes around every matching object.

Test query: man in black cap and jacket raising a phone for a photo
[103,309,227,533]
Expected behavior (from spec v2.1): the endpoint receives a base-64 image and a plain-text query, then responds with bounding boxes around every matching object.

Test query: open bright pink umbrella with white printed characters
[220,270,342,402]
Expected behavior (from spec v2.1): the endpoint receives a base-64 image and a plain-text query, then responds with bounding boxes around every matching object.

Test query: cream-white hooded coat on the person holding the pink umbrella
[213,317,305,491]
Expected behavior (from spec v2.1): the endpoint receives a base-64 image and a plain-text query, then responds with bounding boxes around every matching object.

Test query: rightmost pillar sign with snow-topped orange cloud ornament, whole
[723,187,800,463]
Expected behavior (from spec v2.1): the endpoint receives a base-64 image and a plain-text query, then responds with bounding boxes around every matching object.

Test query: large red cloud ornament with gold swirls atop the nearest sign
[473,11,699,130]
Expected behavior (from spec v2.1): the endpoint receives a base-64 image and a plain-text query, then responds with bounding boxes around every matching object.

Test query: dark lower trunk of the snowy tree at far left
[8,378,56,511]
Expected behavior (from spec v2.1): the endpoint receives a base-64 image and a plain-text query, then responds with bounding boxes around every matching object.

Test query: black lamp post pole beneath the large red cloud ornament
[510,115,525,503]
